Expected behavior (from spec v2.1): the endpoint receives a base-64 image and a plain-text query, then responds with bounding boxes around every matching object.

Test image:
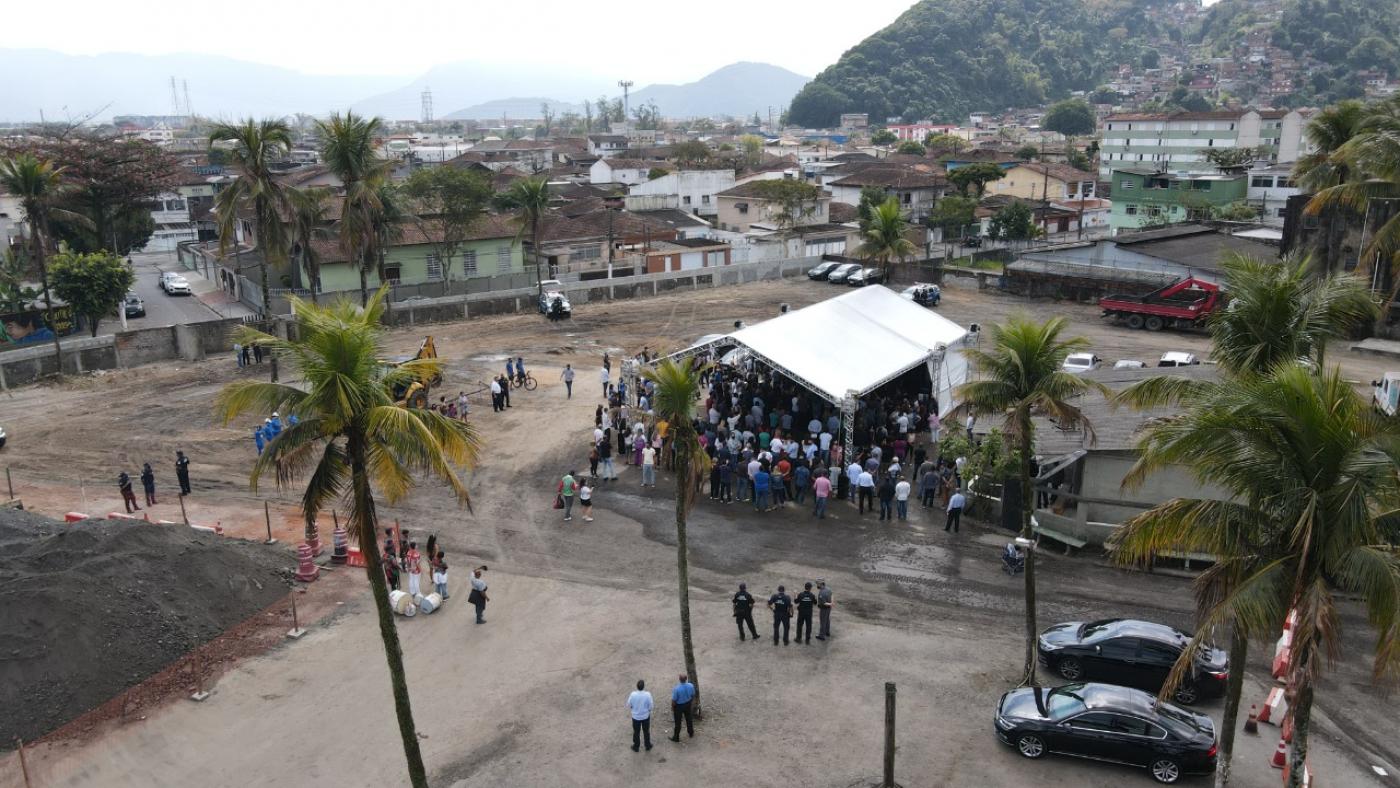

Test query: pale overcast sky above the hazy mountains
[6,0,929,85]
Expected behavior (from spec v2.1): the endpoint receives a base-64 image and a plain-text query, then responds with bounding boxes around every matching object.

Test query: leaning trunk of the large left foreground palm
[346,434,428,788]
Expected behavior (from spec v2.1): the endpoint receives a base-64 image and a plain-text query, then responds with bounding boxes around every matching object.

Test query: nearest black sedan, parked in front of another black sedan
[995,684,1217,784]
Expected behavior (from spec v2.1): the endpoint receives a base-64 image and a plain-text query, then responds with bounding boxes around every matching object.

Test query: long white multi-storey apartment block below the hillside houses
[1099,109,1306,178]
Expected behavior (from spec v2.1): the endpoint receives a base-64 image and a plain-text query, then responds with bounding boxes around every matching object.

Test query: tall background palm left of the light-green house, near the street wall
[209,118,291,384]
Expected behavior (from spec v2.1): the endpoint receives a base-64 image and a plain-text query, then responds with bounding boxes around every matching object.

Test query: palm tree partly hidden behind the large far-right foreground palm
[1116,255,1379,787]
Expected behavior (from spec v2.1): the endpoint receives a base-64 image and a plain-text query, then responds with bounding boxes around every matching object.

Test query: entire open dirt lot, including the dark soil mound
[0,279,1400,788]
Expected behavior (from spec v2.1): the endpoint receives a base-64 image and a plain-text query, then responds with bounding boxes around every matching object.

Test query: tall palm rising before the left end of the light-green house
[316,111,392,305]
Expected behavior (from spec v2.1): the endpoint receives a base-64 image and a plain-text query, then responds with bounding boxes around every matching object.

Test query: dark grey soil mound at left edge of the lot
[0,509,293,749]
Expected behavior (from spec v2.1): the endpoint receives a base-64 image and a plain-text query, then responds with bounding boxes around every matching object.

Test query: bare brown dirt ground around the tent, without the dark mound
[0,281,1400,788]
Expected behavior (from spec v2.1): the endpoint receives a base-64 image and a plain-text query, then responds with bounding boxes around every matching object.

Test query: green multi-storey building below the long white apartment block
[1109,168,1249,235]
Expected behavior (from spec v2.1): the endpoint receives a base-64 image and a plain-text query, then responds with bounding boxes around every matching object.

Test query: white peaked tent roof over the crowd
[697,287,967,402]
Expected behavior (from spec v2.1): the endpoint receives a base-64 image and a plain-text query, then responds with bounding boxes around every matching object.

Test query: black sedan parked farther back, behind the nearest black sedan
[1037,619,1229,705]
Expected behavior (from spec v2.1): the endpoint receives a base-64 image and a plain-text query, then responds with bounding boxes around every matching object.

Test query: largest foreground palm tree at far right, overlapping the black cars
[1112,361,1400,785]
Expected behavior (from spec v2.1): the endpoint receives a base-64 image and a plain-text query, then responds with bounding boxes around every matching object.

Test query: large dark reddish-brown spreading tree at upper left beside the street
[3,133,179,255]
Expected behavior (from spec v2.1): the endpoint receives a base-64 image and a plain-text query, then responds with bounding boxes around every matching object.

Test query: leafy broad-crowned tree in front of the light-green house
[399,167,493,279]
